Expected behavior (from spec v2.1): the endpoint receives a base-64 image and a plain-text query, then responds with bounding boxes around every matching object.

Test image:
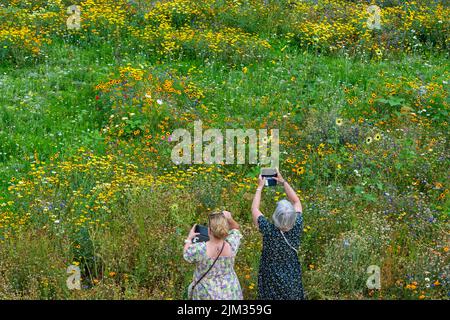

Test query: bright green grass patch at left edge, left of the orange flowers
[0,42,149,190]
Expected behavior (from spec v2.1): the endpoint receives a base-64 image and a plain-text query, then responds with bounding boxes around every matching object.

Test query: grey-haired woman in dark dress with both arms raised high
[252,172,304,300]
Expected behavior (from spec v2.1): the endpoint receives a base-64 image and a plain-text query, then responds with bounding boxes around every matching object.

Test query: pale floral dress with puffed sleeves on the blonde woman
[184,229,243,300]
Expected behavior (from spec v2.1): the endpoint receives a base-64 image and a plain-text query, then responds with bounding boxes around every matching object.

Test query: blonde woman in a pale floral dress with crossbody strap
[183,211,242,300]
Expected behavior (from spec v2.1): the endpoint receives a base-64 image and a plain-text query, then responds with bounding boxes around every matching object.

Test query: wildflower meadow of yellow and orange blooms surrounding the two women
[0,0,450,300]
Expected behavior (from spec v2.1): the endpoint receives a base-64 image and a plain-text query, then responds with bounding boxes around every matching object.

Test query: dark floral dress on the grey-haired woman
[258,212,304,300]
